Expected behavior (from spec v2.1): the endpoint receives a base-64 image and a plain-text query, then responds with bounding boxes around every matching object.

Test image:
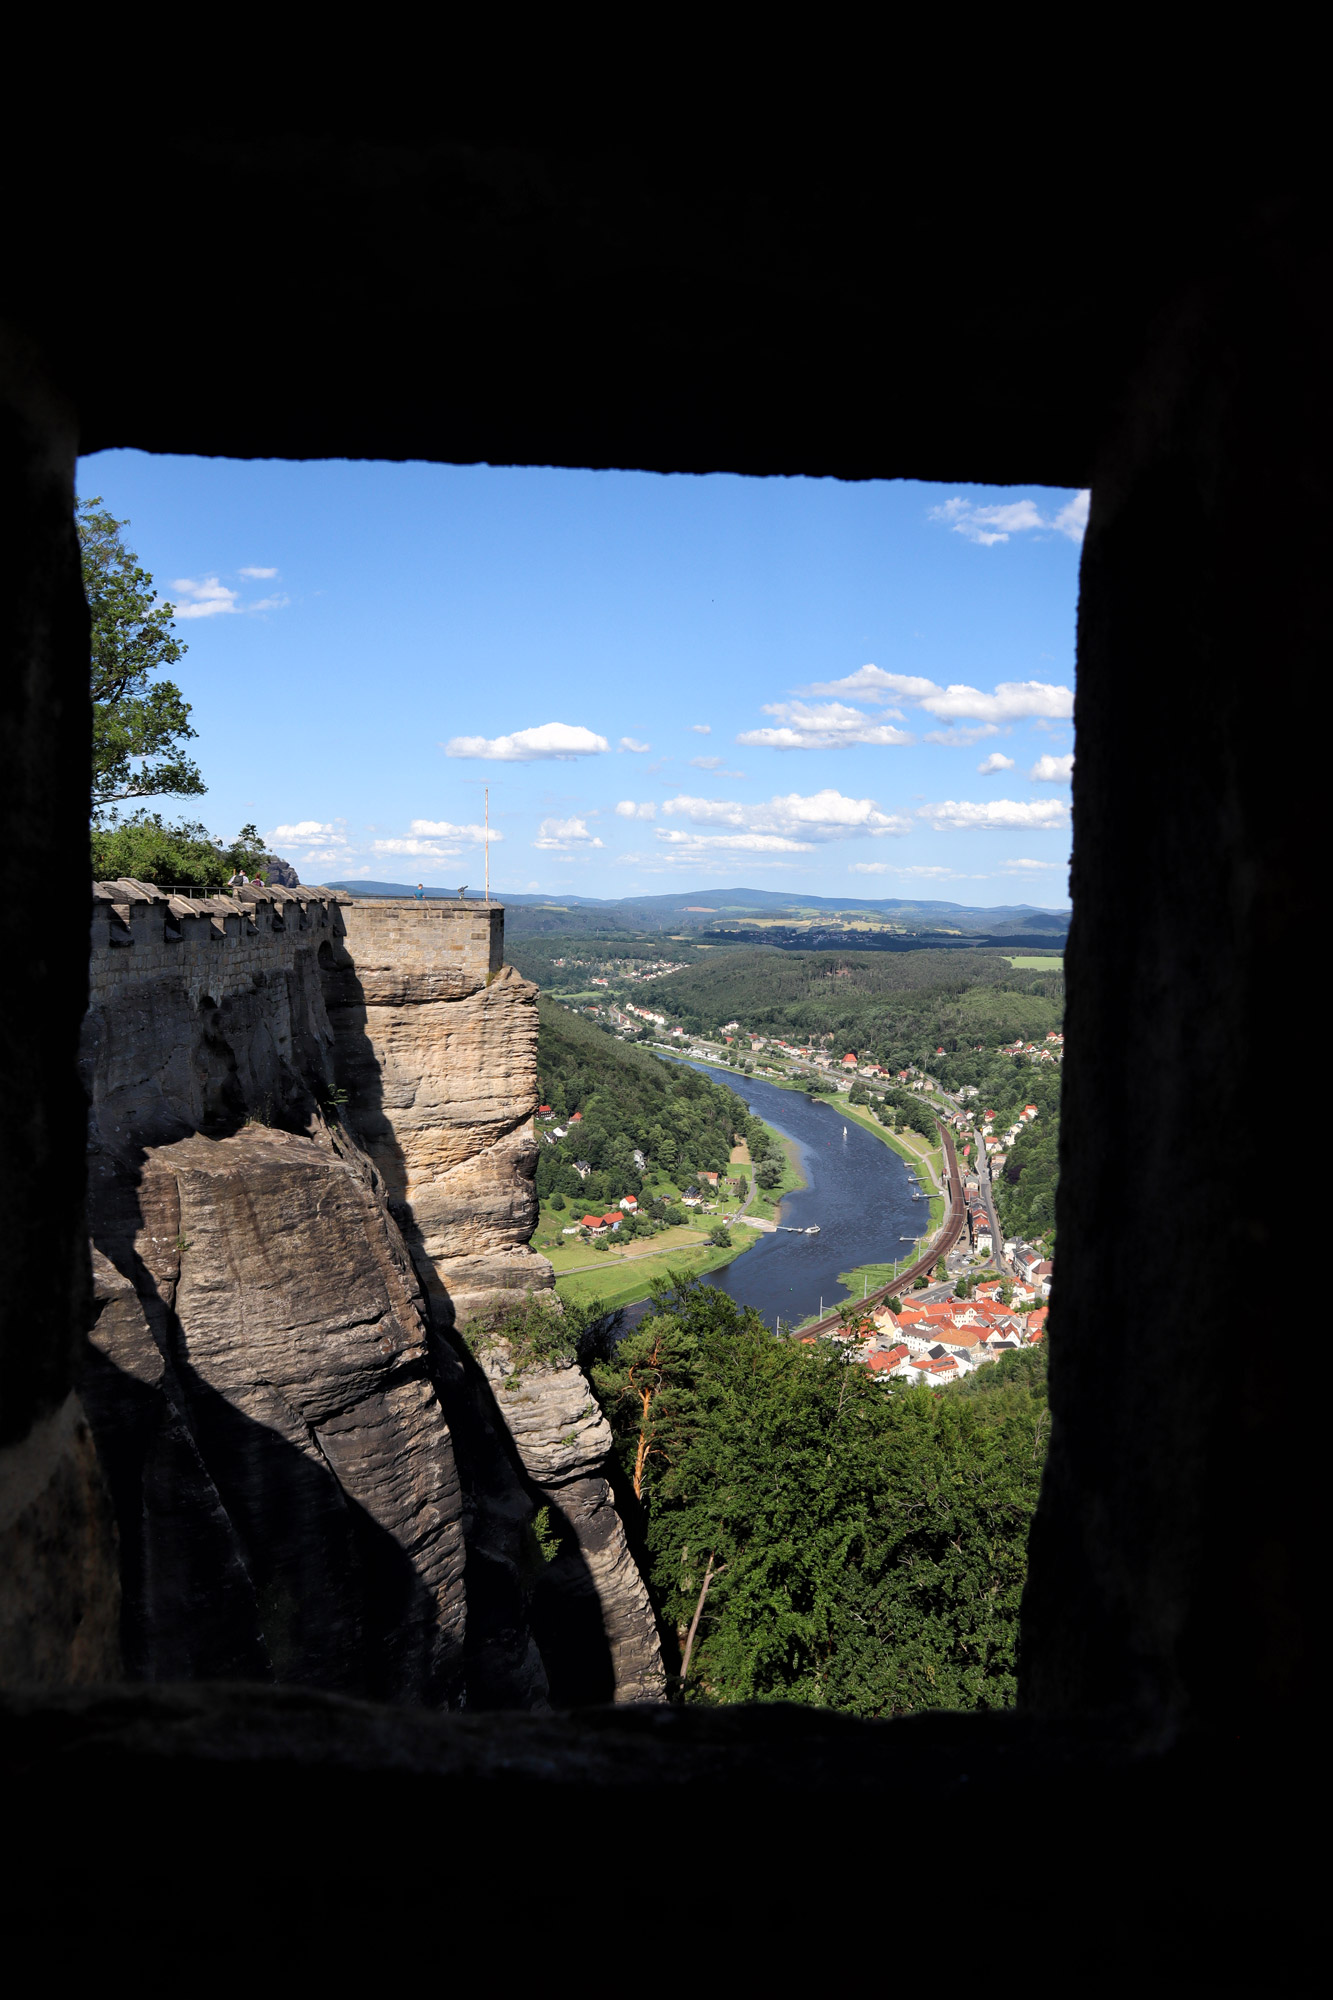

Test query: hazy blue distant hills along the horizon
[328,882,1069,950]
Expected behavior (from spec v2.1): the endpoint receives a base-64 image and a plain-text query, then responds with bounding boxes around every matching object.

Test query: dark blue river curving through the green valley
[626,1062,931,1326]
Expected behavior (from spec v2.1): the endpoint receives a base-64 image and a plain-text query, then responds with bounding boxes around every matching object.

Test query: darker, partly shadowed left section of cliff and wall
[82,882,464,1704]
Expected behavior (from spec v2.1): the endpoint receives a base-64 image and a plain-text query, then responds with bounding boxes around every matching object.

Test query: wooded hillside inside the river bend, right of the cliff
[536,994,753,1206]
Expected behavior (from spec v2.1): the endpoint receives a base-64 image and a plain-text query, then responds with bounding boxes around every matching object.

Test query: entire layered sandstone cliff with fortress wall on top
[80,882,662,1708]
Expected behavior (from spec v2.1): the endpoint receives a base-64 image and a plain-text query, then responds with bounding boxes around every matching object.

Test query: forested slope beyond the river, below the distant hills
[632,948,1065,1068]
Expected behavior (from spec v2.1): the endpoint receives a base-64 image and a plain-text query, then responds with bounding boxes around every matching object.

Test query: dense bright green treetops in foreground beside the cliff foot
[592,1280,1047,1716]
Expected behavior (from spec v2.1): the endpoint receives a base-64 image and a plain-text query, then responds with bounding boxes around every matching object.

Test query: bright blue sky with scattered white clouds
[80,452,1087,908]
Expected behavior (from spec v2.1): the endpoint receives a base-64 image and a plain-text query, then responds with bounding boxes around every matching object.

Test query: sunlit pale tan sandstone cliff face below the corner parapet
[324,904,664,1702]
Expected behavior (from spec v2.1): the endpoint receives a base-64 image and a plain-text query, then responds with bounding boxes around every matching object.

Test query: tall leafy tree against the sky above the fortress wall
[78,496,206,816]
